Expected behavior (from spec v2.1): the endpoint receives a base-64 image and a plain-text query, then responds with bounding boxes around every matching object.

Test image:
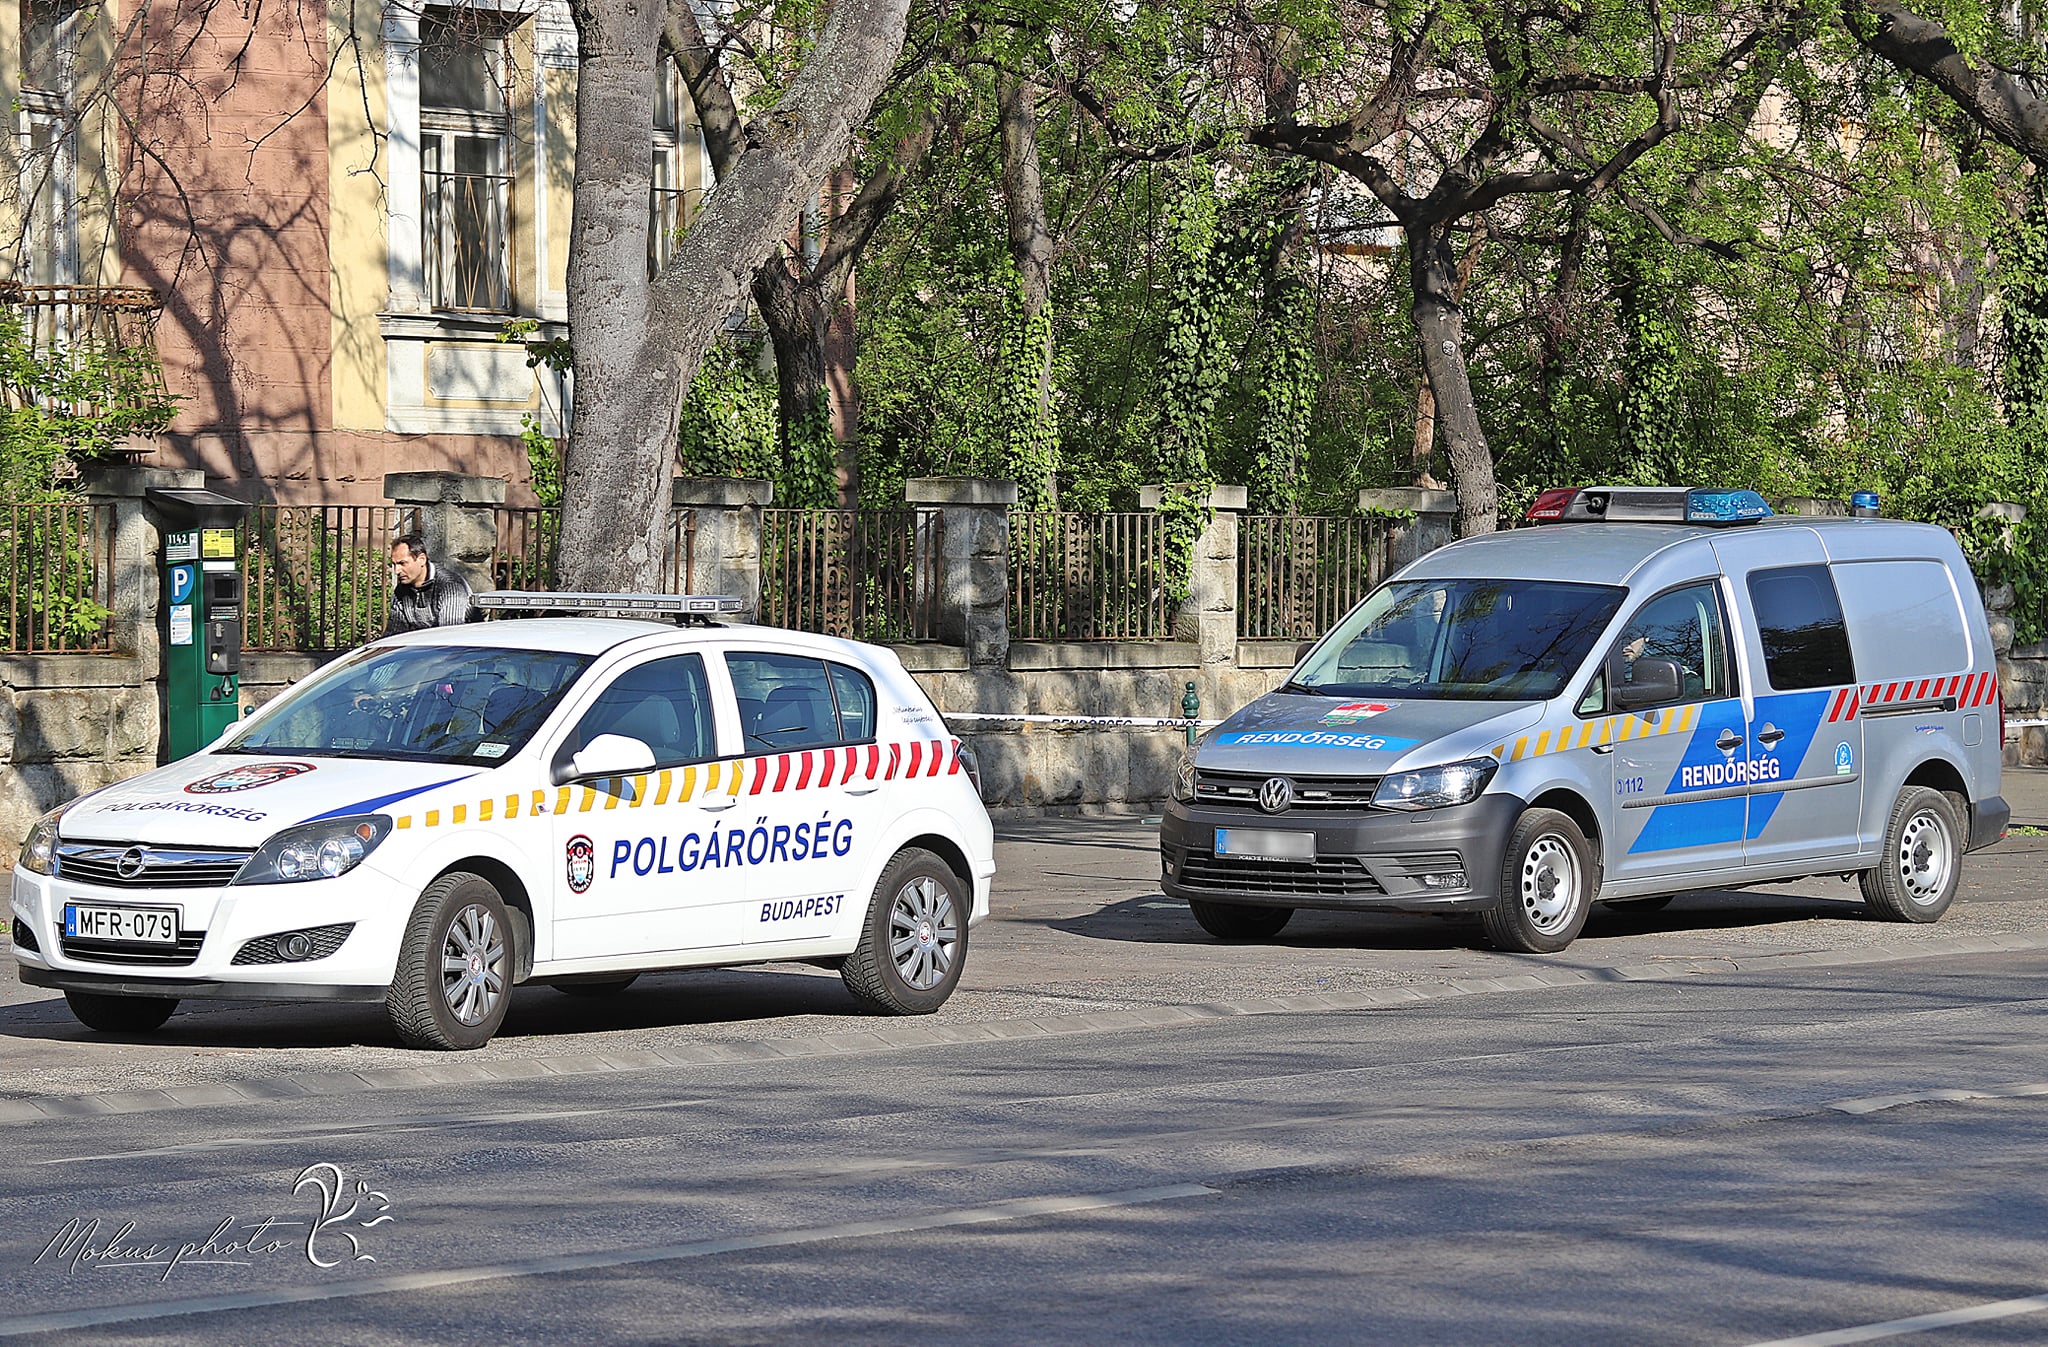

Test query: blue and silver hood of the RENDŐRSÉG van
[1196,692,1544,776]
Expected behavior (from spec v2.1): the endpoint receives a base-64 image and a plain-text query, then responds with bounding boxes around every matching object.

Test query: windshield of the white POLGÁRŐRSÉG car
[219,645,590,766]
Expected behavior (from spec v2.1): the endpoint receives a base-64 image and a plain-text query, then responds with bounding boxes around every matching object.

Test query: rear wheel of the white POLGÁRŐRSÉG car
[840,848,973,1015]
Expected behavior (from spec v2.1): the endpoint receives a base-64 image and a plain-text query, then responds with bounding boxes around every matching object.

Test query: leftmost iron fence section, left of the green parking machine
[0,502,115,655]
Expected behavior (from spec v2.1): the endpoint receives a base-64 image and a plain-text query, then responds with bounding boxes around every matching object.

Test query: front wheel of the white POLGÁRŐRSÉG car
[385,870,518,1052]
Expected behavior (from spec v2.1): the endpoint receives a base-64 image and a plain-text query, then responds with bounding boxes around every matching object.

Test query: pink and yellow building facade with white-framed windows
[0,0,711,504]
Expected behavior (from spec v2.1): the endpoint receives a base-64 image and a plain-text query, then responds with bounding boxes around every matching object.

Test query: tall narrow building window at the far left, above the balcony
[14,0,82,285]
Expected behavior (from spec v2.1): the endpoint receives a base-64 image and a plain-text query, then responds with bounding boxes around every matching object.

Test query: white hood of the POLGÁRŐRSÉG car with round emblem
[57,753,491,850]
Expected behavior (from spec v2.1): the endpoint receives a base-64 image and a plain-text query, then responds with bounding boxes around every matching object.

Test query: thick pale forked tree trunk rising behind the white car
[557,0,909,592]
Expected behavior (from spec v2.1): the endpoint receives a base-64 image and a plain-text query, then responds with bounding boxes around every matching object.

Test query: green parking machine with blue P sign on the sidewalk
[150,487,248,759]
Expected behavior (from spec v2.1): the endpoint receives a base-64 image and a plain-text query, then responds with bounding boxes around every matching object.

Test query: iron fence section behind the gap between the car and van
[1010,510,1174,641]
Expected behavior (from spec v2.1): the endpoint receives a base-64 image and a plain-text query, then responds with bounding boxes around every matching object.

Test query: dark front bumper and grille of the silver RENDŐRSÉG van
[1159,794,1524,913]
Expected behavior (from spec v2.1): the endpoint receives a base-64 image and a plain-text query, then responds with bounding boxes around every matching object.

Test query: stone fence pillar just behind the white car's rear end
[903,477,1018,667]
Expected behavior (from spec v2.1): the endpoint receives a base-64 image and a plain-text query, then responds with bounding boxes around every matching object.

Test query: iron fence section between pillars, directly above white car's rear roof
[762,510,946,641]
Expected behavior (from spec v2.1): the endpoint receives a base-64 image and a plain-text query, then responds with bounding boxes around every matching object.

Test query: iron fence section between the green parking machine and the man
[242,506,410,653]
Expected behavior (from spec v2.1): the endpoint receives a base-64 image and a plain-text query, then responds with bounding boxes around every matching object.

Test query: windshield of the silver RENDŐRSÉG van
[1280,579,1626,702]
